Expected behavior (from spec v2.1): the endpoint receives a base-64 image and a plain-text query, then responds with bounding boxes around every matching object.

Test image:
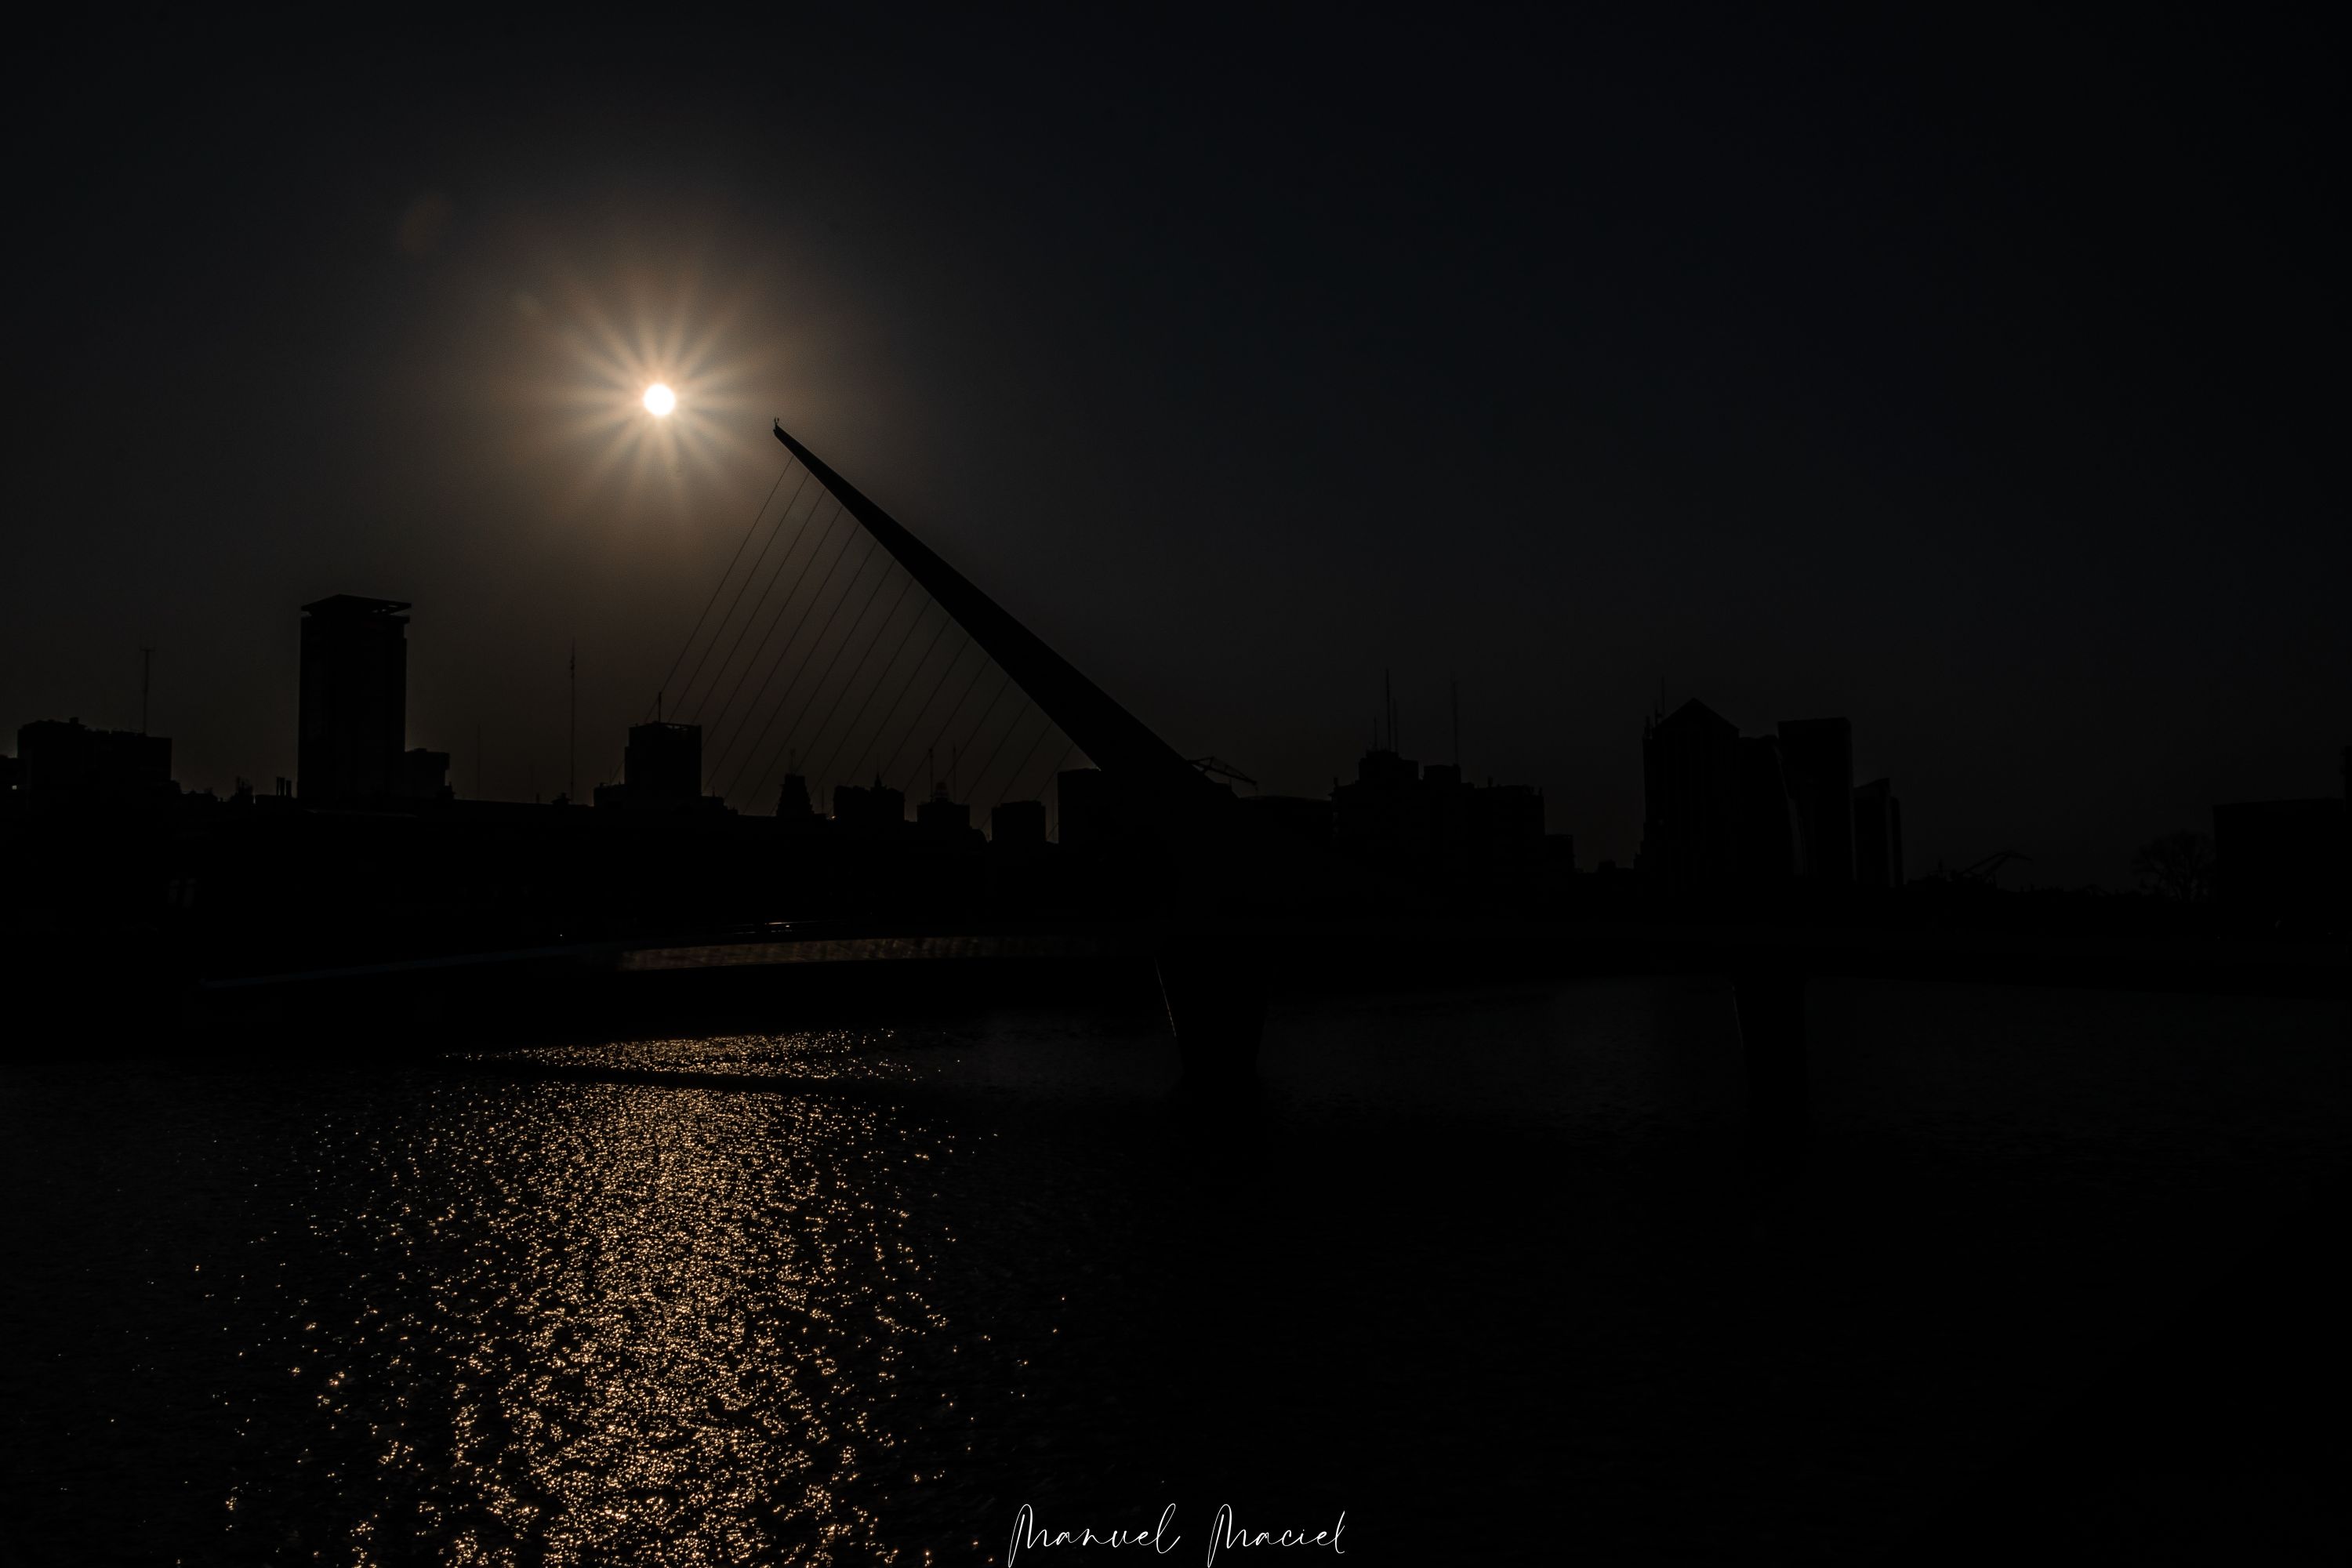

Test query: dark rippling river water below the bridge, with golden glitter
[0,980,2352,1563]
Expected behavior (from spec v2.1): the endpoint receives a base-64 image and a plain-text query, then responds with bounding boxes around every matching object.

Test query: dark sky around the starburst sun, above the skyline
[0,7,2352,884]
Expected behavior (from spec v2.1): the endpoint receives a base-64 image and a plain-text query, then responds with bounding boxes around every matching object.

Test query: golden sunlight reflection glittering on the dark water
[278,1034,955,1563]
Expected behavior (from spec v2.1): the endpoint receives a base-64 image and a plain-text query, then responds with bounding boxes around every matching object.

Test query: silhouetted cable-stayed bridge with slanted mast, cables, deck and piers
[188,423,2352,1175]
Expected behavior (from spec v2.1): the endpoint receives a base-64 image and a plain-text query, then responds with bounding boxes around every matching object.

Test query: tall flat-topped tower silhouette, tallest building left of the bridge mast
[294,593,409,801]
